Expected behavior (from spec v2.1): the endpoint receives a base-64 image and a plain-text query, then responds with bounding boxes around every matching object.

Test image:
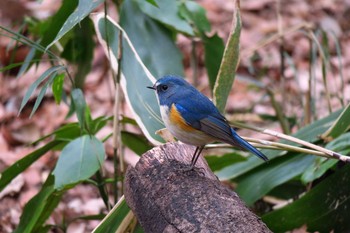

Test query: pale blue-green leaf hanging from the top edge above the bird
[135,0,194,35]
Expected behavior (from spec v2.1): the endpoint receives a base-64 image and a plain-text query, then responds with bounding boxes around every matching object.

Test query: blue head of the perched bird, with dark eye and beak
[148,75,197,106]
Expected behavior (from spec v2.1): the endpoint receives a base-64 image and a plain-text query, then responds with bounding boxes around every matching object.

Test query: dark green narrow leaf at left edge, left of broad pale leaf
[0,140,62,192]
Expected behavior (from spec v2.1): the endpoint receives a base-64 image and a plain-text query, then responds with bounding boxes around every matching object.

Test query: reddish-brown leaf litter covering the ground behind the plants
[0,0,350,232]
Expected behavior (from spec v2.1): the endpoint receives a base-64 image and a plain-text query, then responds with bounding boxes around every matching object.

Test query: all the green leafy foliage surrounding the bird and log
[0,0,350,232]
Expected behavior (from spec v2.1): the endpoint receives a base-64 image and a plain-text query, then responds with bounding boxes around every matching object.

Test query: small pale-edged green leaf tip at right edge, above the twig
[321,103,350,140]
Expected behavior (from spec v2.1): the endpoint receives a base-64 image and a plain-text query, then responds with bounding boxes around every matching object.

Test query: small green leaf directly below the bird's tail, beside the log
[205,153,247,171]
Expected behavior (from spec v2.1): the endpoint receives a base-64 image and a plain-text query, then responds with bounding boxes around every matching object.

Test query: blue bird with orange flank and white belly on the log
[147,75,268,169]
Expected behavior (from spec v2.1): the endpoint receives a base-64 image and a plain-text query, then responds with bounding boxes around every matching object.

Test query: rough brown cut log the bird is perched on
[125,143,271,233]
